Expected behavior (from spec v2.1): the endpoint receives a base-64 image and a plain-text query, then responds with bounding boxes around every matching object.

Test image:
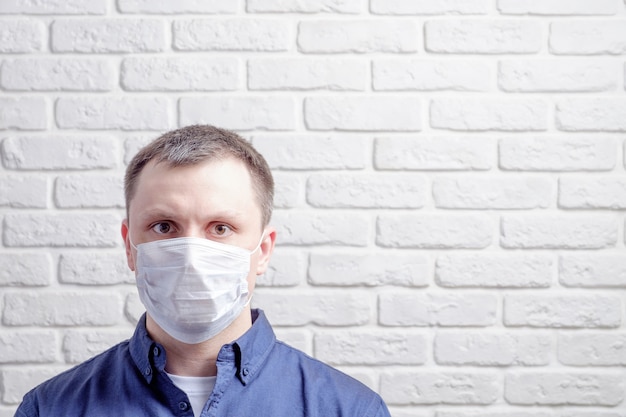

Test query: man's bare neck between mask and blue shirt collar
[146,307,252,376]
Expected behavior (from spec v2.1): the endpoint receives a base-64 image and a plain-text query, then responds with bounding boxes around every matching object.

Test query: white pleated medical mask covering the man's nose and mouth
[130,236,263,344]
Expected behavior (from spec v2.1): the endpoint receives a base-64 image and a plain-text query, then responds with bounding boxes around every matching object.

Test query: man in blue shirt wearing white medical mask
[16,126,389,417]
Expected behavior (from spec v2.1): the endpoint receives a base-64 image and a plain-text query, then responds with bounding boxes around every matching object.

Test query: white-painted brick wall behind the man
[0,0,626,417]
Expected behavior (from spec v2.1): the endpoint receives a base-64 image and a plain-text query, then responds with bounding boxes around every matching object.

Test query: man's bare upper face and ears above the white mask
[122,158,276,293]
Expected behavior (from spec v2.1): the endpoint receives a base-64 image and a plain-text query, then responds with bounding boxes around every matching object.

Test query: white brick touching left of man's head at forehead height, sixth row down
[54,174,124,208]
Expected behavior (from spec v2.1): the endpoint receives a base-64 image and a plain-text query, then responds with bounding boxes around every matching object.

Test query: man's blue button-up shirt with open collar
[15,310,389,417]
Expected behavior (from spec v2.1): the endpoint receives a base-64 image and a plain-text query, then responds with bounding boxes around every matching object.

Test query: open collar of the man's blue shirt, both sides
[129,309,276,385]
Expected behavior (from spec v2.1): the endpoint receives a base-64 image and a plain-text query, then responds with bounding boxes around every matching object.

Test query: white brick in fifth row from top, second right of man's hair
[374,136,495,171]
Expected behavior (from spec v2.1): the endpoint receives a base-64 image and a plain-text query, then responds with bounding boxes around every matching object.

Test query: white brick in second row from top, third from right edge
[297,19,420,54]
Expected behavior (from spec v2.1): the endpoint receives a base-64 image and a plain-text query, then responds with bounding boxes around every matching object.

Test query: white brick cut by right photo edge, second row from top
[549,20,626,55]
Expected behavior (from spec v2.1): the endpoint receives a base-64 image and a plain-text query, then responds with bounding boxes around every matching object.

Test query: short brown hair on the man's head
[124,125,274,226]
